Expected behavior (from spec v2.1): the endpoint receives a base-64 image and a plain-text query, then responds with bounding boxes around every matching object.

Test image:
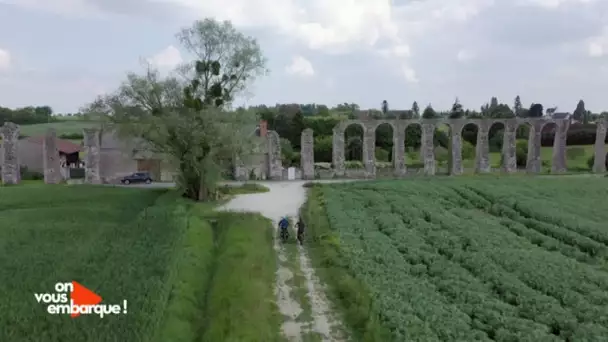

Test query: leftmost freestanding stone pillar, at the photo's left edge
[0,122,21,185]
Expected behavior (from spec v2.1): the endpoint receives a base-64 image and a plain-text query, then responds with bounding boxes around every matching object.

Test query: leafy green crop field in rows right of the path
[303,177,608,341]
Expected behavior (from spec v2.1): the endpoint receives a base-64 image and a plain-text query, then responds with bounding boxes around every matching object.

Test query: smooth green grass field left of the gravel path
[0,184,280,342]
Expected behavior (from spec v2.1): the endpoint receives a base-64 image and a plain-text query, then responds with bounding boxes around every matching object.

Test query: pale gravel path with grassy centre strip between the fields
[220,181,345,342]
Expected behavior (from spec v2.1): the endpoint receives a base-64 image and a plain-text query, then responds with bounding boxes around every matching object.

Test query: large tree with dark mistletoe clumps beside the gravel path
[82,19,266,200]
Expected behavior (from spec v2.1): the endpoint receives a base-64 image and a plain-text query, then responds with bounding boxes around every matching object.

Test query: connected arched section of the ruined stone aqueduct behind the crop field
[324,118,580,178]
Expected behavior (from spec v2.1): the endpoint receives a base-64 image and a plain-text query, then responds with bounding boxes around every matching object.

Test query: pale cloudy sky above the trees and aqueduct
[0,0,608,112]
